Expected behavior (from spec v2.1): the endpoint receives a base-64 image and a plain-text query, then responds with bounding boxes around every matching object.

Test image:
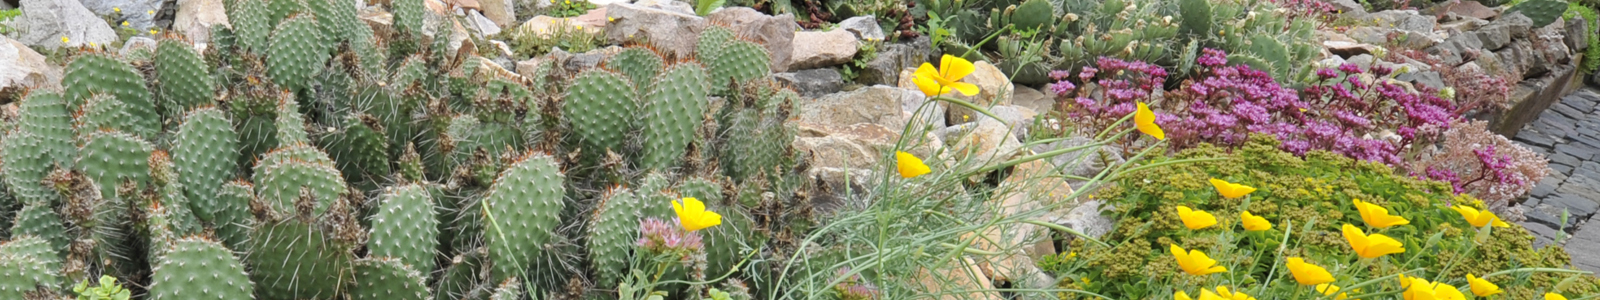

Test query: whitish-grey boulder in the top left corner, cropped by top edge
[11,0,118,49]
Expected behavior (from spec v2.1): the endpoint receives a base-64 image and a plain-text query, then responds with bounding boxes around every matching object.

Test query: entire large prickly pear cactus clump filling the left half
[0,0,810,300]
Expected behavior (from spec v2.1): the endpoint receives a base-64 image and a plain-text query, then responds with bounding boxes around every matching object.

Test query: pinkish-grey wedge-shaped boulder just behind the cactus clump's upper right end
[709,6,800,72]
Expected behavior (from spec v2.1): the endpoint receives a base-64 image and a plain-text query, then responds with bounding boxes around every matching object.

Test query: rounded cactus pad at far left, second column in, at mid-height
[77,131,155,204]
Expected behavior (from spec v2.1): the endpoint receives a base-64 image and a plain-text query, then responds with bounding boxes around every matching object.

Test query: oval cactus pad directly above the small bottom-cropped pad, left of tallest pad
[366,184,440,270]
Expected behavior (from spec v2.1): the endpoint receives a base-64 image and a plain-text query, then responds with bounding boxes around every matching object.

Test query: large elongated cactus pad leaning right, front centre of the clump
[483,155,566,281]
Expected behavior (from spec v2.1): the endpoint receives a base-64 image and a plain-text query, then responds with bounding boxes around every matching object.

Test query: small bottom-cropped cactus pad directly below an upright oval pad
[350,257,429,300]
